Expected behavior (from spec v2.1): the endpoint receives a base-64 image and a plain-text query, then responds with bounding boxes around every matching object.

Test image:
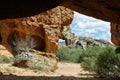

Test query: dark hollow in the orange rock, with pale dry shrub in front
[7,31,45,54]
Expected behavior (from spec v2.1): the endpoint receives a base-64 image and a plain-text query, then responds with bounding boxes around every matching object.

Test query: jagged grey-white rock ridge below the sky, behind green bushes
[60,26,113,49]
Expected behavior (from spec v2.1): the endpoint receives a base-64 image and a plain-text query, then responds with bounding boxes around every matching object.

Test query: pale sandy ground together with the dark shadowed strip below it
[0,62,110,80]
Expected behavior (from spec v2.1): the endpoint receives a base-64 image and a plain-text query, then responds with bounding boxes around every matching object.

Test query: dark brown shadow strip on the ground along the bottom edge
[0,74,113,80]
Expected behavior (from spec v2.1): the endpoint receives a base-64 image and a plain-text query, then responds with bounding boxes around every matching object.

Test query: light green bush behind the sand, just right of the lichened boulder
[56,47,82,62]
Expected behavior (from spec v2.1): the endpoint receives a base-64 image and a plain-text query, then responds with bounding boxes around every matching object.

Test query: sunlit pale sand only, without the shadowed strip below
[0,62,92,77]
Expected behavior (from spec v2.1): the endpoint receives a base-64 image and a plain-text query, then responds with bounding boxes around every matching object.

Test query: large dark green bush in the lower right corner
[96,48,120,78]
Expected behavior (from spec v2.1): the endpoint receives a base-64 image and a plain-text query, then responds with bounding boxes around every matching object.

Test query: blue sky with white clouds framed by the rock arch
[70,12,111,41]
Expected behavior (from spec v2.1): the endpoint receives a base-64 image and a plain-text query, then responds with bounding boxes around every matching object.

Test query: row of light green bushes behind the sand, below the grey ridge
[56,46,103,63]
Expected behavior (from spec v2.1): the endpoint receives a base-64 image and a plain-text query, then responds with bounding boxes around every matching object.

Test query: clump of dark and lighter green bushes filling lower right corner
[81,47,120,79]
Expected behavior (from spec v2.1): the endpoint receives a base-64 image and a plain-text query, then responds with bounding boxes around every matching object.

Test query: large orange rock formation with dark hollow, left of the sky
[0,6,73,70]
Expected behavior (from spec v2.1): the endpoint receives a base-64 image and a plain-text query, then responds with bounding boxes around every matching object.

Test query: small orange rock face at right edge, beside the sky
[111,23,120,46]
